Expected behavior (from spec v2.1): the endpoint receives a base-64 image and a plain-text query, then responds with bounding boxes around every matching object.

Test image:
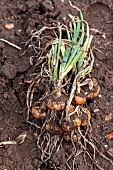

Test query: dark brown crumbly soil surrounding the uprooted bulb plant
[0,0,113,170]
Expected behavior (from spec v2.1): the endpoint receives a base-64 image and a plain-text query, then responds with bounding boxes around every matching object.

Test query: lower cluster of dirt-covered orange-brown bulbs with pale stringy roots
[27,76,113,170]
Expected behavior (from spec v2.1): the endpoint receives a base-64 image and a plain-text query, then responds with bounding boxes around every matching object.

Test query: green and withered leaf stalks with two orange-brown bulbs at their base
[43,8,94,115]
